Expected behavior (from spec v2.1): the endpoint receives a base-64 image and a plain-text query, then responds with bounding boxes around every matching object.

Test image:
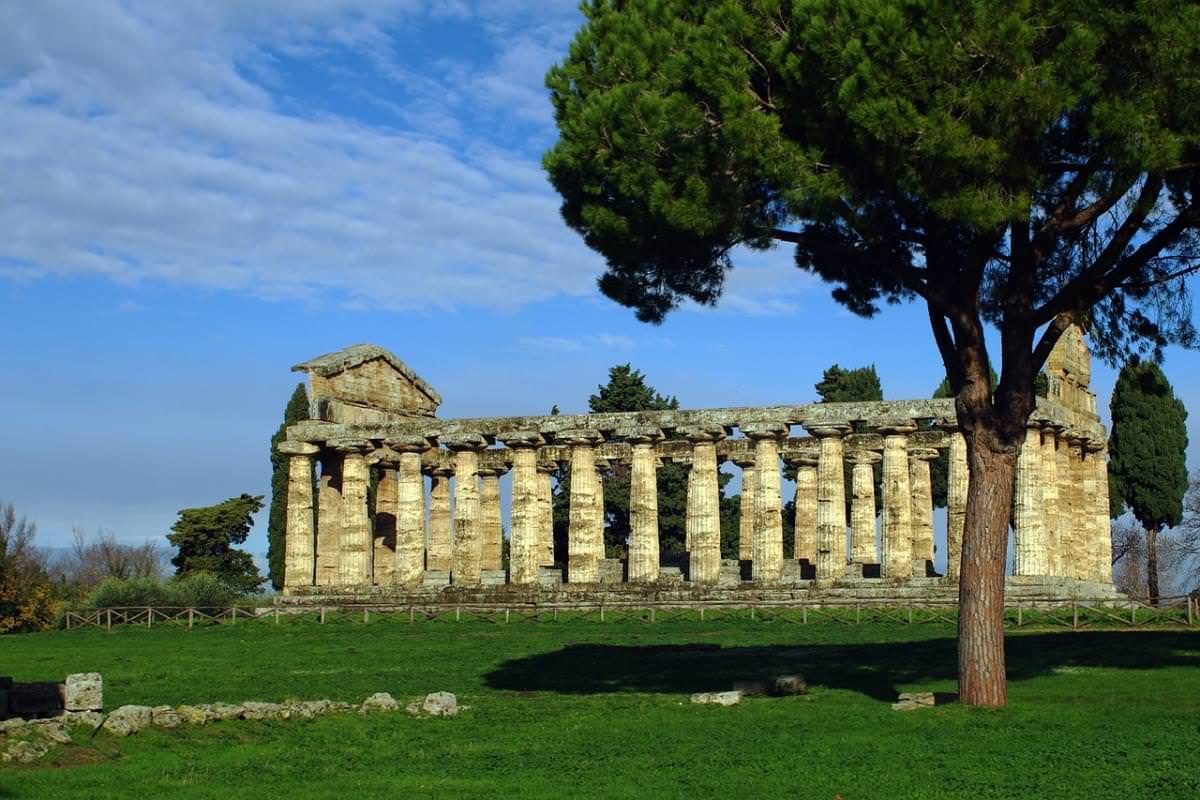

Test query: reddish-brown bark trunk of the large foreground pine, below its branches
[959,426,1016,706]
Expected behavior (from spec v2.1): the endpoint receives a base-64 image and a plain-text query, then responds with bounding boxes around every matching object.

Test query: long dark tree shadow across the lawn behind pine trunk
[486,631,1200,703]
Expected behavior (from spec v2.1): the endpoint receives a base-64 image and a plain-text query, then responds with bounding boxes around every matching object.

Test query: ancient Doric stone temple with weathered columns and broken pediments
[280,329,1112,600]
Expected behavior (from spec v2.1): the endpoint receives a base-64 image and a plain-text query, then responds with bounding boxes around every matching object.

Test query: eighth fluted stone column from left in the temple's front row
[680,426,720,585]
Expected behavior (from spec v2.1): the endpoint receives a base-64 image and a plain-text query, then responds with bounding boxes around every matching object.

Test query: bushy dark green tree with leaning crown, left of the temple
[167,494,263,591]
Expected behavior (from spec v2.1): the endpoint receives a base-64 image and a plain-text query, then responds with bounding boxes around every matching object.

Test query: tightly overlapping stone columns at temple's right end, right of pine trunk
[1013,420,1112,583]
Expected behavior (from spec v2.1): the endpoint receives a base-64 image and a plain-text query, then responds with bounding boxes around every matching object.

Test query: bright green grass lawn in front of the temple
[0,618,1200,800]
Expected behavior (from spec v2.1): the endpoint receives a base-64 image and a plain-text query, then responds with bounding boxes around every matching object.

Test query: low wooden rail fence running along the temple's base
[66,596,1200,631]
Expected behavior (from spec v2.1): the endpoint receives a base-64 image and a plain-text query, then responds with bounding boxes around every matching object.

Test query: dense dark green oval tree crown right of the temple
[1109,361,1188,530]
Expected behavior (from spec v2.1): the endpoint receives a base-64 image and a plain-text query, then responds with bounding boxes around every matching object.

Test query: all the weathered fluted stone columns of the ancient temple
[281,422,1111,587]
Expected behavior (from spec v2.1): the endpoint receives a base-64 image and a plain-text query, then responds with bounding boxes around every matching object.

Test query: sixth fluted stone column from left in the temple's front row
[558,429,604,583]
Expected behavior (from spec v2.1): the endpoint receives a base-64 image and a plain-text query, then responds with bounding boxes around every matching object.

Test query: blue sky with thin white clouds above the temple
[0,0,1200,575]
